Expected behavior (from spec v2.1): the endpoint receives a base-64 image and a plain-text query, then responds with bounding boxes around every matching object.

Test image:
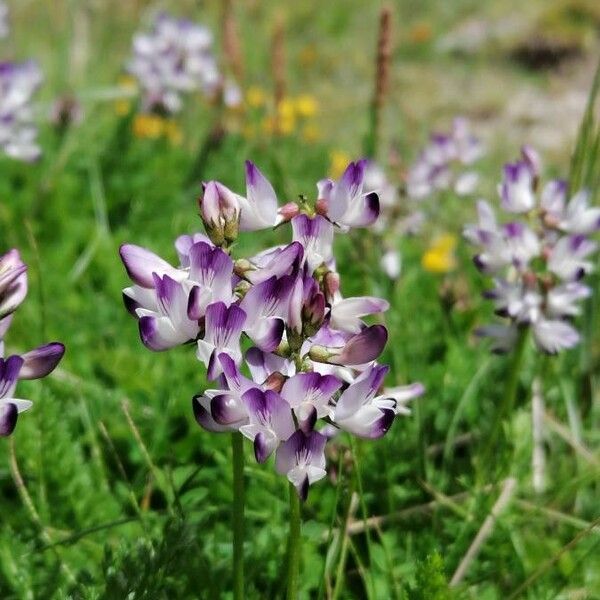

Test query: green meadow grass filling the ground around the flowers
[0,0,600,600]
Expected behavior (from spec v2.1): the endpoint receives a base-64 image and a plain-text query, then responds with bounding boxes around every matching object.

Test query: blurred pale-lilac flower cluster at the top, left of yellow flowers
[127,14,239,114]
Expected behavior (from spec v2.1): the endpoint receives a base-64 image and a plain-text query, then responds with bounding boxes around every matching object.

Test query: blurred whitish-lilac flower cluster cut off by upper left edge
[0,61,42,161]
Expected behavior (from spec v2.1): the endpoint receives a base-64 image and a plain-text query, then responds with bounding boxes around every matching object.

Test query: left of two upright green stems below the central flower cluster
[231,431,244,600]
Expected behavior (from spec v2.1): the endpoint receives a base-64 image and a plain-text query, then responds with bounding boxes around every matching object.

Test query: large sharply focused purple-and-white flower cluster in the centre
[121,161,423,498]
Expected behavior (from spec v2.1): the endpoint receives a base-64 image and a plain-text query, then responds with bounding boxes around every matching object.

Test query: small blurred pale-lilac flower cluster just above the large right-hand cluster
[406,117,484,200]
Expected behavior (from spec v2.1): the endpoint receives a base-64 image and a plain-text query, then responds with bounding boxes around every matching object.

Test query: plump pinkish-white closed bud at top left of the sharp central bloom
[199,181,240,246]
